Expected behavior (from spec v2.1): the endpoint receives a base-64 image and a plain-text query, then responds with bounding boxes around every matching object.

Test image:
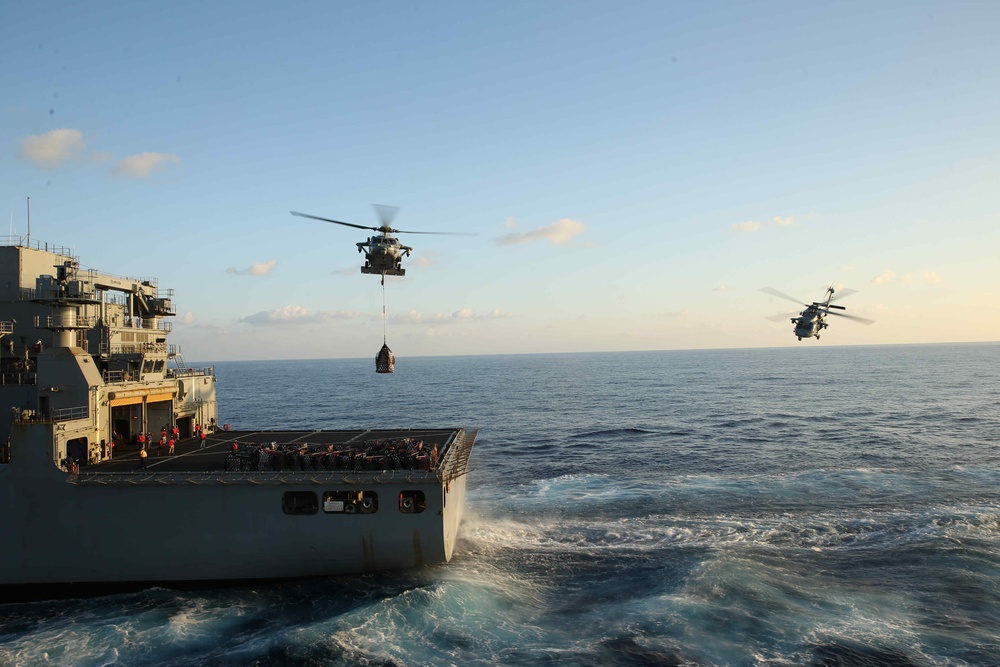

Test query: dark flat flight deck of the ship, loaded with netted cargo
[88,428,462,476]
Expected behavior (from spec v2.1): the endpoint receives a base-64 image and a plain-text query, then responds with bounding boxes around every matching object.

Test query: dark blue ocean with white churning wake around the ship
[0,348,1000,667]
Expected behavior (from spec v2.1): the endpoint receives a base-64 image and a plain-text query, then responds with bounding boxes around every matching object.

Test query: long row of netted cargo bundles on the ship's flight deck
[225,438,440,472]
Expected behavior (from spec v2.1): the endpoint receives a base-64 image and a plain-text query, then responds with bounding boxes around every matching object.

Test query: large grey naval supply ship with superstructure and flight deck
[0,237,477,598]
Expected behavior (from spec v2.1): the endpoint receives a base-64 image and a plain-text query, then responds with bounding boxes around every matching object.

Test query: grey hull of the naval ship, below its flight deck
[0,428,475,595]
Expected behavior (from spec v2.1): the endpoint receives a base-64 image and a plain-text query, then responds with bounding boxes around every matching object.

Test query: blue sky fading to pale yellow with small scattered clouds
[0,0,1000,363]
